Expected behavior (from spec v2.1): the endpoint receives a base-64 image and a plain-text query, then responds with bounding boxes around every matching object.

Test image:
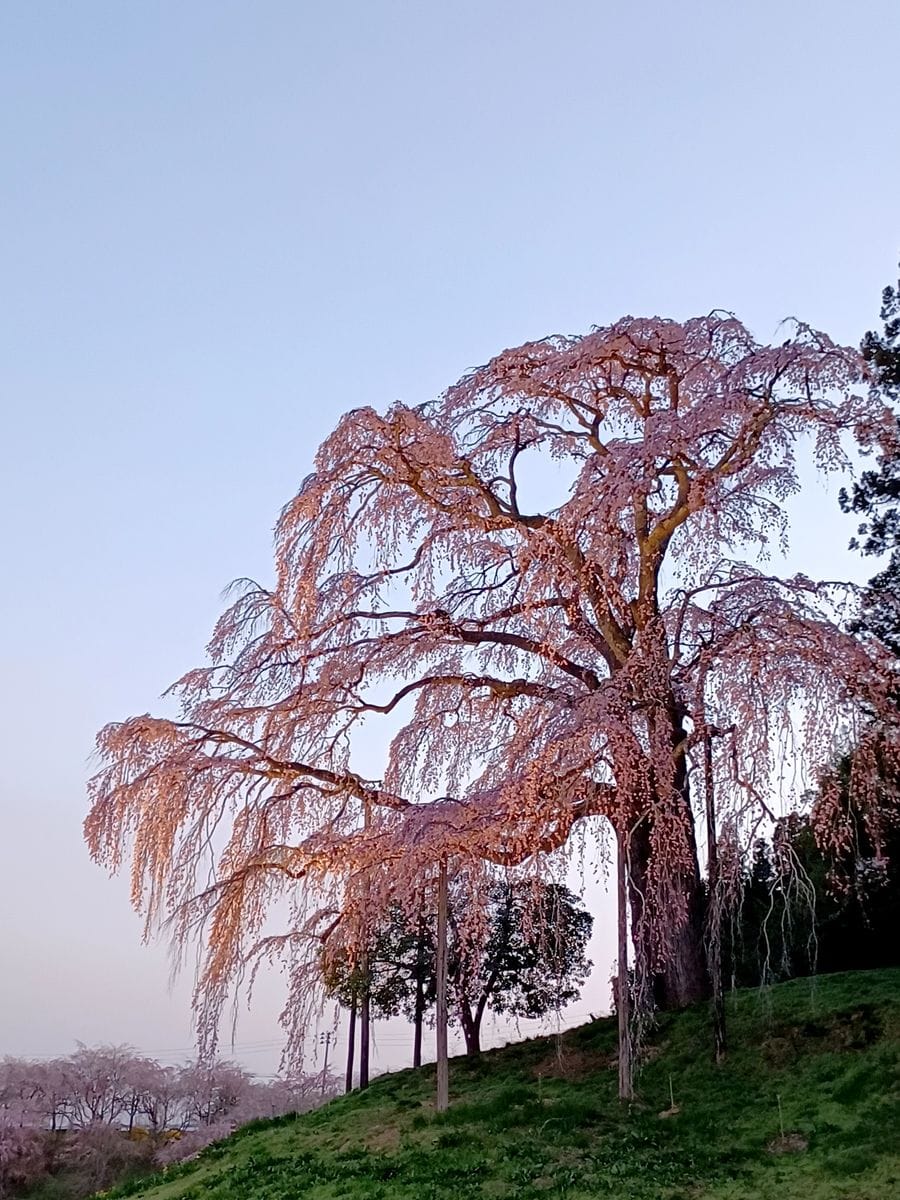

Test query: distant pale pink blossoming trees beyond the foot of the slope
[0,1046,336,1200]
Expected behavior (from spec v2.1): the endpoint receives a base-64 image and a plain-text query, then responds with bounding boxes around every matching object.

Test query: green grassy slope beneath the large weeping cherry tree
[103,971,900,1200]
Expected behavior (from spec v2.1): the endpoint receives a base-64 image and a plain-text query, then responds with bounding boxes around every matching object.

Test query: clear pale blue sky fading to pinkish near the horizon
[0,0,900,1070]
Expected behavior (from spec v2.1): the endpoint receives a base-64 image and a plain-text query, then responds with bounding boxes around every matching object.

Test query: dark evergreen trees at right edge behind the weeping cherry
[726,265,900,986]
